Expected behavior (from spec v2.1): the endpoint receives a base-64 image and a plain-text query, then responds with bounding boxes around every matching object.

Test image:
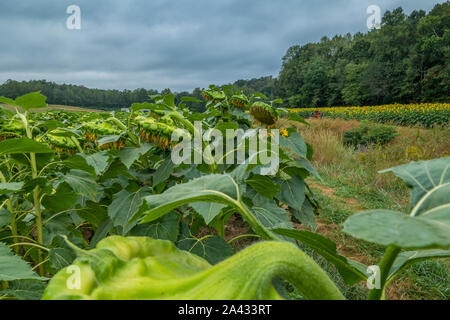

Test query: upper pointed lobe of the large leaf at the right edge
[380,157,450,209]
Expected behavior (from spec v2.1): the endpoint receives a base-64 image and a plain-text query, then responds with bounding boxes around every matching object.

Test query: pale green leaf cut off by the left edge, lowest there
[0,242,42,281]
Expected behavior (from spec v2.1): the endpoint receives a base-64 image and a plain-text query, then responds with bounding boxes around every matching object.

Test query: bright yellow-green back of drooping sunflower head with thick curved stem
[43,236,344,300]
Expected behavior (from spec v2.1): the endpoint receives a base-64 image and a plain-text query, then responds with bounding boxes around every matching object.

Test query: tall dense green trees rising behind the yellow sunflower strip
[278,1,450,107]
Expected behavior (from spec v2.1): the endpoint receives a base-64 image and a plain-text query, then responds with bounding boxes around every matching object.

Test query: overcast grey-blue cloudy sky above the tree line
[0,0,445,91]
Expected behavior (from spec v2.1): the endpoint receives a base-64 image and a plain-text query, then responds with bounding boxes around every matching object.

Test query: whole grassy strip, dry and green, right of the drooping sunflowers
[284,119,450,300]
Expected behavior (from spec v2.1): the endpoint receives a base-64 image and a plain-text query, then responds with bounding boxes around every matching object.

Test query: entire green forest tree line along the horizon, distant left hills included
[0,1,450,111]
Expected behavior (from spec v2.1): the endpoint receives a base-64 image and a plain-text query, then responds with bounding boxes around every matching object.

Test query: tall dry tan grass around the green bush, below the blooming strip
[296,119,450,192]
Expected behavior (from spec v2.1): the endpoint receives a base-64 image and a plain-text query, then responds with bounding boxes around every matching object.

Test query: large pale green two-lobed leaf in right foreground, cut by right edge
[344,158,450,250]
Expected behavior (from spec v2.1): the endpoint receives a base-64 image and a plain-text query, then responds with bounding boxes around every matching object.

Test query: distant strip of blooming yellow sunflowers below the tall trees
[288,103,450,128]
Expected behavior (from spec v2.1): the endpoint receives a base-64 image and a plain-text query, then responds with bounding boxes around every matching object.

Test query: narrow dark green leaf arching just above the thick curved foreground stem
[272,229,367,285]
